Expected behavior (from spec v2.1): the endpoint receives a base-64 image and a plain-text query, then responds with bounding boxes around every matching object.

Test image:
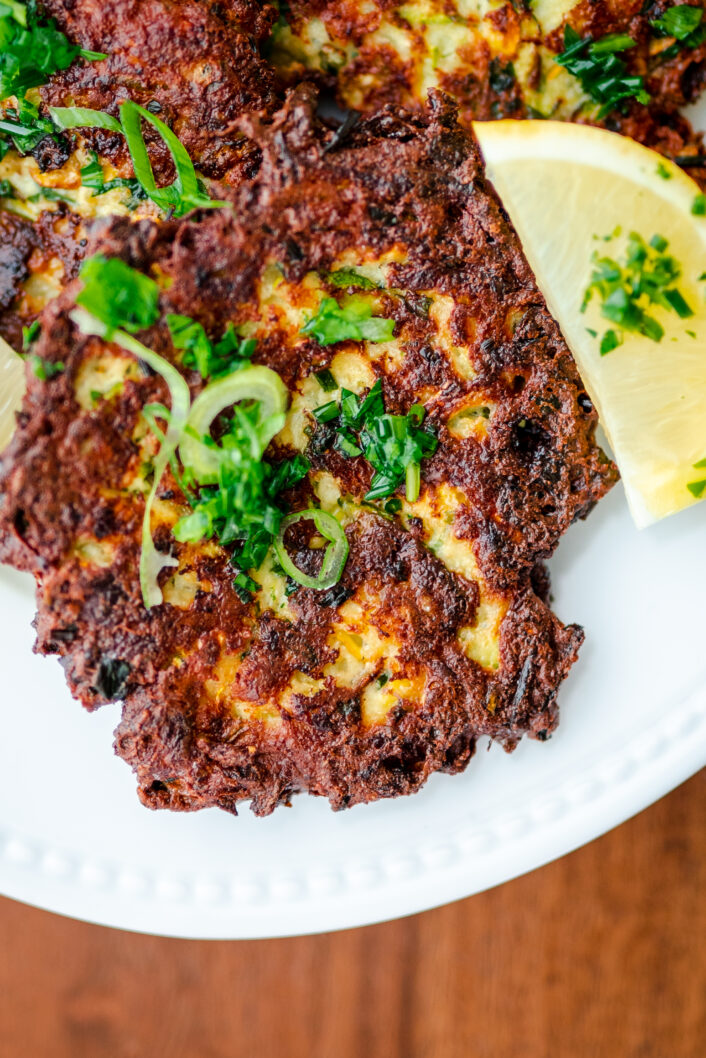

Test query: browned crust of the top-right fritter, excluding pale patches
[272,0,706,184]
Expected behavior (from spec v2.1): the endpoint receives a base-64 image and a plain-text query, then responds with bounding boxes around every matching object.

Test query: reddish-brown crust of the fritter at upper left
[41,0,276,182]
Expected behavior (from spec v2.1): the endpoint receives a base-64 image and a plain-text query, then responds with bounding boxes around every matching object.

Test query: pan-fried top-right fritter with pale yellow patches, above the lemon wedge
[269,0,706,182]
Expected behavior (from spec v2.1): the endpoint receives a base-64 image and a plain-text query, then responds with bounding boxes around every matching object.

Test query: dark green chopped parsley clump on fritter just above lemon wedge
[556,25,650,117]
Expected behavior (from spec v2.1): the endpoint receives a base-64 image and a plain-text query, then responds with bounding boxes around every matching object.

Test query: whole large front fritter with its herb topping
[0,90,615,813]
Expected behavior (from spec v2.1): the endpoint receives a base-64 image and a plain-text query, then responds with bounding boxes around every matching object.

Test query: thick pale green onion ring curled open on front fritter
[179,364,289,485]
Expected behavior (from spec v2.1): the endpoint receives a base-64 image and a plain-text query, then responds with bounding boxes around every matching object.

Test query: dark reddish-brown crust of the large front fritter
[0,90,616,813]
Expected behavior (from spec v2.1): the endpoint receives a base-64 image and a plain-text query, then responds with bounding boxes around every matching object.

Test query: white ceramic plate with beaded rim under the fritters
[0,101,706,938]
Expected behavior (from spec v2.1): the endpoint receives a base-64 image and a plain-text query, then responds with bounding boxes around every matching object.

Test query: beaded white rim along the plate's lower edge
[0,676,706,941]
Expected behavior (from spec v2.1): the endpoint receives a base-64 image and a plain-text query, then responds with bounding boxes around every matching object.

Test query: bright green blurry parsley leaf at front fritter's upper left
[76,254,160,334]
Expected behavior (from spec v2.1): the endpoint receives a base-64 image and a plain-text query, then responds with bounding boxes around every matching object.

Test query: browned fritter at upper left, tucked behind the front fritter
[0,0,277,349]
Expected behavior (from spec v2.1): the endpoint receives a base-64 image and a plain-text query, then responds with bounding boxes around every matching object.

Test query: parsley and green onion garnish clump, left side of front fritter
[74,255,319,608]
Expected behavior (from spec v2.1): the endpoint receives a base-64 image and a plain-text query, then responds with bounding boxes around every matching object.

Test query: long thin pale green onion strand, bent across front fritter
[71,309,191,609]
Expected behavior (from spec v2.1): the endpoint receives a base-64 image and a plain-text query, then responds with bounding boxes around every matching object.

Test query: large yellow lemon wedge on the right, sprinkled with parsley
[474,121,706,528]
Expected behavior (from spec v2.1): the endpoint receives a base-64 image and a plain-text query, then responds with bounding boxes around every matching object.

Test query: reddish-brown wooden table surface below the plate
[0,772,706,1058]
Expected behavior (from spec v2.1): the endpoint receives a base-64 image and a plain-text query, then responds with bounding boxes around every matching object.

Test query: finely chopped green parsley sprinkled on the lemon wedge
[581,232,693,355]
